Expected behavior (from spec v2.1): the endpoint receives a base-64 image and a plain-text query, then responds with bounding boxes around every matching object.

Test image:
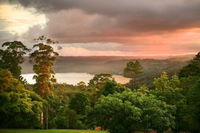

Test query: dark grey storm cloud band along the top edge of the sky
[1,0,200,32]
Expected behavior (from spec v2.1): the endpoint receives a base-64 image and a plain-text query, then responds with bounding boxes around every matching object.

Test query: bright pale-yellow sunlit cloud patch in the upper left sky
[0,4,47,35]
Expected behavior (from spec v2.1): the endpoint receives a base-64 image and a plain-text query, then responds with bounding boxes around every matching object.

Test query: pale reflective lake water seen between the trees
[22,73,130,85]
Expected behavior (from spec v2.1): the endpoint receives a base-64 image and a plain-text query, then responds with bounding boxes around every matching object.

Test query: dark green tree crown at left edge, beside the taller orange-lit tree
[0,41,29,79]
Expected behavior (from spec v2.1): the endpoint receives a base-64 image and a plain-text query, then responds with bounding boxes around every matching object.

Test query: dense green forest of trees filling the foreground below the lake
[0,37,200,133]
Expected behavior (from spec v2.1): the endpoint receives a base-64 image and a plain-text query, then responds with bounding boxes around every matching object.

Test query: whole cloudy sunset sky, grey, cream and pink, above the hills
[0,0,200,56]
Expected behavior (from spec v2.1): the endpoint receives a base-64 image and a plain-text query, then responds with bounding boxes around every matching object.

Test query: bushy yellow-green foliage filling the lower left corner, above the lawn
[0,69,44,128]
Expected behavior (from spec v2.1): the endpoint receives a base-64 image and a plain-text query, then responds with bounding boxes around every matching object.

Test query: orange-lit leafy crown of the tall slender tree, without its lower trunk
[30,39,58,97]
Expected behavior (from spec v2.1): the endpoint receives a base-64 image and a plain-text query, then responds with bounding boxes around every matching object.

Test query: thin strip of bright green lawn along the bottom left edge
[0,129,107,133]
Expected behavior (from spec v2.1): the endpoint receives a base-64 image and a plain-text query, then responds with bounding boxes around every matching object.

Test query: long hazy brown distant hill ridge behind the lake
[22,55,193,76]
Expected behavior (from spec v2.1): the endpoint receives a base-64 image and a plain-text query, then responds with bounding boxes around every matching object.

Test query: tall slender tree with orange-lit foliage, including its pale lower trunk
[30,36,58,129]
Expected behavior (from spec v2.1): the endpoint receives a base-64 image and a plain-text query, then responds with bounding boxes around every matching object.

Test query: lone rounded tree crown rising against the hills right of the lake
[124,60,142,78]
